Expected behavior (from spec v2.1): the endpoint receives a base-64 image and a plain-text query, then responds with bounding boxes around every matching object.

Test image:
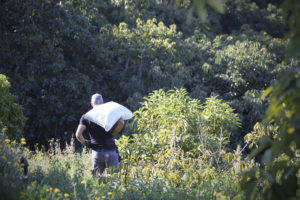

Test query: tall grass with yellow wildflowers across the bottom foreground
[0,131,244,200]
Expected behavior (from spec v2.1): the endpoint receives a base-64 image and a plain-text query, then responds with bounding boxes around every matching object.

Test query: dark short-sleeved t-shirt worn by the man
[79,115,116,150]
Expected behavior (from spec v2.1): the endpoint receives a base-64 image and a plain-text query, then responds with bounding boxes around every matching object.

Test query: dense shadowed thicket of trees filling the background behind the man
[0,0,292,146]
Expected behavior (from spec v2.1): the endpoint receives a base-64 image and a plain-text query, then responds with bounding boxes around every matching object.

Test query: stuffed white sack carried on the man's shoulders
[85,101,132,131]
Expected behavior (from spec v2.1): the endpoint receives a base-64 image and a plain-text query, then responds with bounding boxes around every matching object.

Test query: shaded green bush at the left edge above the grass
[0,74,26,139]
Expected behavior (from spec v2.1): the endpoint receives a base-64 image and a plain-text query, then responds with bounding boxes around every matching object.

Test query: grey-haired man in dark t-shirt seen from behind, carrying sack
[76,94,124,175]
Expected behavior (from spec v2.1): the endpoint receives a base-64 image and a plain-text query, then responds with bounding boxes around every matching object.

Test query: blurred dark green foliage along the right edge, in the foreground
[242,1,300,199]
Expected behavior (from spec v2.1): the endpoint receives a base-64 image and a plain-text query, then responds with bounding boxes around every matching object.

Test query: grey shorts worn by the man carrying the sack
[92,149,119,174]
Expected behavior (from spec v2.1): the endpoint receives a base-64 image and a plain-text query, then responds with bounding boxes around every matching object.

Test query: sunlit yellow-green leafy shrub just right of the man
[134,89,240,157]
